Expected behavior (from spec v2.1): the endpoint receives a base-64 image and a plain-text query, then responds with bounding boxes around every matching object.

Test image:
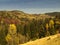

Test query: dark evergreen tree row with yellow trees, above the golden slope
[17,18,60,40]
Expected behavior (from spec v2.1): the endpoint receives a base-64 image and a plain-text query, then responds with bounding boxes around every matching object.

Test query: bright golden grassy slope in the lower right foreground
[20,34,60,45]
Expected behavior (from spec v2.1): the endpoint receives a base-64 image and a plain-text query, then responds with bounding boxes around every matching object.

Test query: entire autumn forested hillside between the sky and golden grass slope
[0,10,60,45]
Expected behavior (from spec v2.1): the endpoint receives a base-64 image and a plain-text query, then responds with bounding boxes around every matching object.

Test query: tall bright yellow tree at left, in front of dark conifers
[6,24,19,45]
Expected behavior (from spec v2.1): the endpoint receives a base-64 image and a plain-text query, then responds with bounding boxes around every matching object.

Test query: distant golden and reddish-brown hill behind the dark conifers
[0,10,51,24]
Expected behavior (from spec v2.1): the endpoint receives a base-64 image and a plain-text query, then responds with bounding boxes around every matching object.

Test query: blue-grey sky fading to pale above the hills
[0,0,60,14]
